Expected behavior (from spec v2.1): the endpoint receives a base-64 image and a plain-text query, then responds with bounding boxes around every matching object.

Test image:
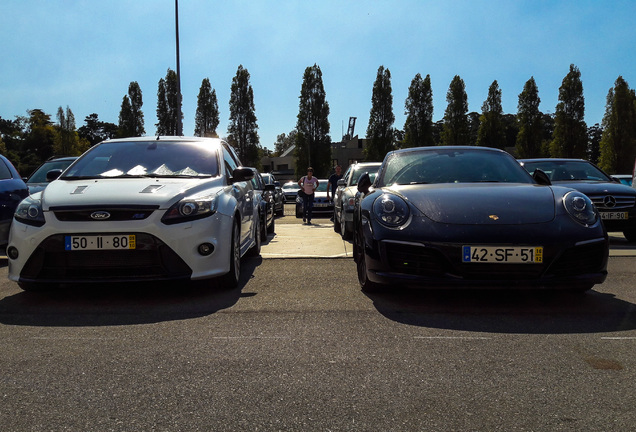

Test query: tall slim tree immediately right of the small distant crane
[364,66,395,161]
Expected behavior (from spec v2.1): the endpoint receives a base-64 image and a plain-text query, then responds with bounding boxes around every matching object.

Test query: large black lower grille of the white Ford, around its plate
[20,233,192,282]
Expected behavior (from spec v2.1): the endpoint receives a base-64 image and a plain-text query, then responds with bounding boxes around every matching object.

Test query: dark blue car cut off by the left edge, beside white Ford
[0,155,29,246]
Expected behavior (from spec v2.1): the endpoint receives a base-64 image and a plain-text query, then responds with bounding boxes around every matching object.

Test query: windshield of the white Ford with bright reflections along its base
[62,141,219,180]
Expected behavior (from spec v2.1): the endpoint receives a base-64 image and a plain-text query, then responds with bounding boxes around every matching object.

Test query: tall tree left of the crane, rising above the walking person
[296,64,331,177]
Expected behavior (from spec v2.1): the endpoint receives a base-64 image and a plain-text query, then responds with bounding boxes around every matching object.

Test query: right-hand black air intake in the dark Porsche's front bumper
[547,242,607,276]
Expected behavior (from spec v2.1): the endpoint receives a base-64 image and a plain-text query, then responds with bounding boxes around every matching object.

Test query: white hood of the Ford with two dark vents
[42,177,225,211]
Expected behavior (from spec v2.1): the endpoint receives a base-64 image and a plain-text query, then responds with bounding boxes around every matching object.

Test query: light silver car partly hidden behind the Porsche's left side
[333,162,382,240]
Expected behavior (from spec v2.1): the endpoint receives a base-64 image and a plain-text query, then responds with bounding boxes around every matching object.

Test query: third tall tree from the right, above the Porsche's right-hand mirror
[516,77,543,158]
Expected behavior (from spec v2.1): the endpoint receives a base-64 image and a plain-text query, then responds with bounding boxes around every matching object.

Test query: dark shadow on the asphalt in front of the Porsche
[367,289,636,334]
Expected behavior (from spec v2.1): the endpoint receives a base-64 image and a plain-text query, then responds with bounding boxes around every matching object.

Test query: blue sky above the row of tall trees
[0,0,636,148]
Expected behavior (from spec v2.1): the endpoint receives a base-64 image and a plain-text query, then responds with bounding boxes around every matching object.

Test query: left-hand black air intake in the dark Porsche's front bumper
[383,242,448,276]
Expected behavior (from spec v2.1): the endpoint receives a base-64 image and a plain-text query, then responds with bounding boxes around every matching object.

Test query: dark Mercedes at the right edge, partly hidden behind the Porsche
[519,158,636,242]
